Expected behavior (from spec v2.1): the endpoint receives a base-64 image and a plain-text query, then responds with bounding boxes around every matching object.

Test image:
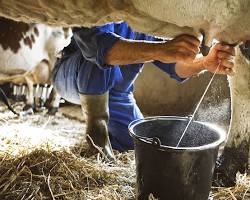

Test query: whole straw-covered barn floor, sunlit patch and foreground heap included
[0,103,250,200]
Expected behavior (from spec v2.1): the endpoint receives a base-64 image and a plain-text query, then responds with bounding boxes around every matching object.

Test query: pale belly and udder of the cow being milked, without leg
[0,0,250,43]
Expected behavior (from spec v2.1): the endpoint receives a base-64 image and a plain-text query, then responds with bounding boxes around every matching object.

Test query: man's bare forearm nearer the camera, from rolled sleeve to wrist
[105,40,163,65]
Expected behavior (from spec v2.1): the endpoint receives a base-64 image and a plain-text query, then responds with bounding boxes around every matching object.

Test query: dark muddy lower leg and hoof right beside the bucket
[213,142,248,187]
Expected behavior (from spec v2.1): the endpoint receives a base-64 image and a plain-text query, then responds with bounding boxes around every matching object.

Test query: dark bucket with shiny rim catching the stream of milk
[129,116,226,200]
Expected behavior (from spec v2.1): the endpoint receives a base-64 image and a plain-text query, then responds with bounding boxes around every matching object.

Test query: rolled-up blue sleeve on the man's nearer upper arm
[74,27,120,69]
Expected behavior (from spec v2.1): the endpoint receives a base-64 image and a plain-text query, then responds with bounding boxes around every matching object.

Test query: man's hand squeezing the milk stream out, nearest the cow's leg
[203,43,235,75]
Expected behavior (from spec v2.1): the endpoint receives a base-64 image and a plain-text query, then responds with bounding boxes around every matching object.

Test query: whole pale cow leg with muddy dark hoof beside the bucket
[214,47,250,186]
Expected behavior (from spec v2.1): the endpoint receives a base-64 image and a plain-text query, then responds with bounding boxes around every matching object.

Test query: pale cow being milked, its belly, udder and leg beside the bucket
[0,0,250,187]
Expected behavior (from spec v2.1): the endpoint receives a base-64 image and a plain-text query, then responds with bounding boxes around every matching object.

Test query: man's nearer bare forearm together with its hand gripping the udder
[105,35,200,65]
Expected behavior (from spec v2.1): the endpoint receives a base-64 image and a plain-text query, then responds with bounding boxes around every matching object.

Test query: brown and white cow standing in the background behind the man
[0,18,72,112]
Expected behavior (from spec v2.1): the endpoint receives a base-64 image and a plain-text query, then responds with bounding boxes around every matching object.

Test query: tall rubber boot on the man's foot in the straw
[80,92,115,160]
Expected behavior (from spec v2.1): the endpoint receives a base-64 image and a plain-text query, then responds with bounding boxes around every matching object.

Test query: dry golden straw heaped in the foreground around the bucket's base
[0,148,250,200]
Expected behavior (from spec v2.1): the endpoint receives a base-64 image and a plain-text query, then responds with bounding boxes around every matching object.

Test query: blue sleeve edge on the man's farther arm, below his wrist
[153,61,188,82]
